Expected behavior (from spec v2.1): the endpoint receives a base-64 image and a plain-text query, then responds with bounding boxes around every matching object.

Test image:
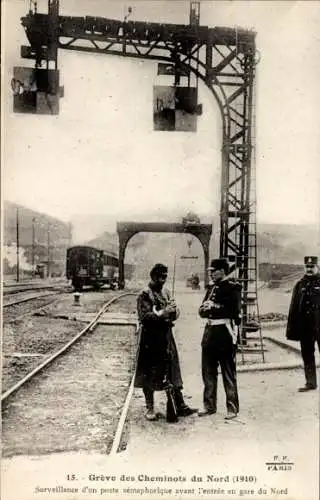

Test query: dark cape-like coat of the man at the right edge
[286,274,320,340]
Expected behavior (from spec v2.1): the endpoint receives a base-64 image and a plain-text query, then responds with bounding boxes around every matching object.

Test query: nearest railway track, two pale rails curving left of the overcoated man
[1,292,137,454]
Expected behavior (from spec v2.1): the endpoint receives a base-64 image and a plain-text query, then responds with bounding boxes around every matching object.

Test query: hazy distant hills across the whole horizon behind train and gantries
[3,201,320,279]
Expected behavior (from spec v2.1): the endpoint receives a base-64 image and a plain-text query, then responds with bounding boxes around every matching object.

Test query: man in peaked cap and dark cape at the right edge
[286,256,320,392]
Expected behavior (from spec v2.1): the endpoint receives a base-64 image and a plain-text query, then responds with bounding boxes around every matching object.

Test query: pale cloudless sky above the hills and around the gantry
[2,0,320,236]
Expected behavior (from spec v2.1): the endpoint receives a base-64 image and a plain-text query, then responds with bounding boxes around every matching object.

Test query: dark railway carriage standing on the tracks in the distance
[66,245,133,292]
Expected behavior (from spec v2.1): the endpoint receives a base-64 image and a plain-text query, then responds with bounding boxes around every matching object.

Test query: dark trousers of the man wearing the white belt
[201,325,239,413]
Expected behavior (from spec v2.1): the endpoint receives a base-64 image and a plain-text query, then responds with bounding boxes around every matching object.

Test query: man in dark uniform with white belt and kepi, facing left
[198,259,241,420]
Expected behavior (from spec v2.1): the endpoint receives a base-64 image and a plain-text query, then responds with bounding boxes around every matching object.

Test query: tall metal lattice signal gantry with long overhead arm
[15,0,262,360]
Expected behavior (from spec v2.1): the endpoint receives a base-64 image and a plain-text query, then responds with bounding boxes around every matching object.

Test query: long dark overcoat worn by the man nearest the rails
[135,284,182,391]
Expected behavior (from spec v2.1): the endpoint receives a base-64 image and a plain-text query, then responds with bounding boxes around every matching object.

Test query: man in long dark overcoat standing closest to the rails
[135,264,197,420]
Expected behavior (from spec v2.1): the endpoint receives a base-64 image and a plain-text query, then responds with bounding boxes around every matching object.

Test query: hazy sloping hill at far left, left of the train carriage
[3,201,72,274]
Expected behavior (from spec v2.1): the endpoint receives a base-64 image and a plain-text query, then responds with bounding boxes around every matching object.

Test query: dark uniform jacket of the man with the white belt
[199,279,241,325]
